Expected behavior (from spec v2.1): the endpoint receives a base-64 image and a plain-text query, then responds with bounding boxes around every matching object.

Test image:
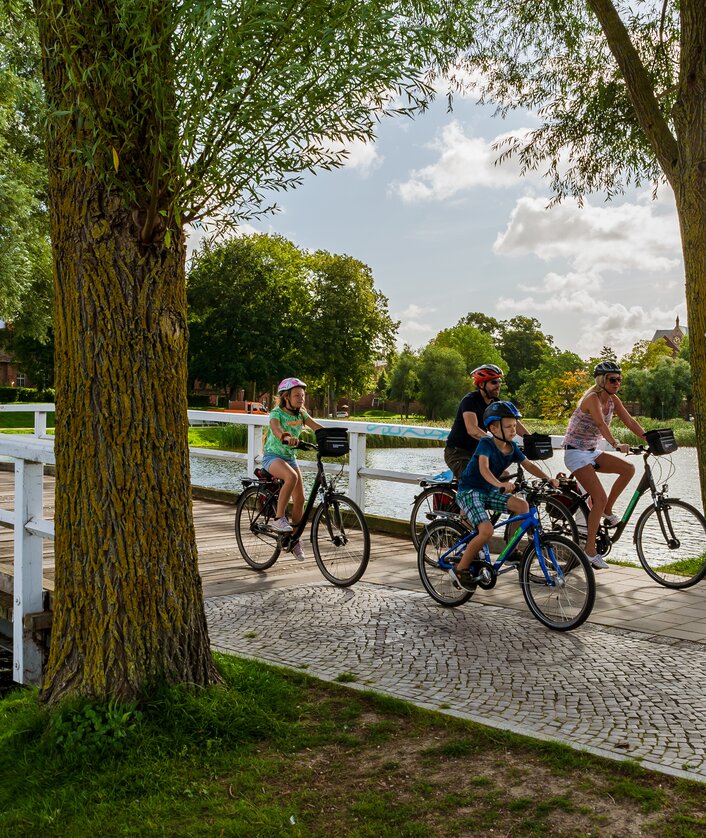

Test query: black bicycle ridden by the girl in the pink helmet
[235,429,370,588]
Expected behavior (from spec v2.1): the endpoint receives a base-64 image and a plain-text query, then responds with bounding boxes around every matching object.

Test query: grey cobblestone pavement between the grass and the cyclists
[206,582,706,782]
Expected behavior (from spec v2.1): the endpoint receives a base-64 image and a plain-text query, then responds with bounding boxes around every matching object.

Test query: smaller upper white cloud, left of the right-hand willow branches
[391,120,525,204]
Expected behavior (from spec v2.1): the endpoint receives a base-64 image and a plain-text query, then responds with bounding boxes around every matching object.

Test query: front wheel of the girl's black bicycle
[311,494,370,588]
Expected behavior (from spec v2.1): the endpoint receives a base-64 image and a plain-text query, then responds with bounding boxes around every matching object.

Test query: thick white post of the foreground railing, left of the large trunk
[12,460,44,684]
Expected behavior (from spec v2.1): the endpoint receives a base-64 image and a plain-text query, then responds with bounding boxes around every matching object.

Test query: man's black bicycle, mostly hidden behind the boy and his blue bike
[409,466,585,550]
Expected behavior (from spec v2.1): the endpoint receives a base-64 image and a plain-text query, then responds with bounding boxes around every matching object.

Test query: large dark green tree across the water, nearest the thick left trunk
[187,235,309,397]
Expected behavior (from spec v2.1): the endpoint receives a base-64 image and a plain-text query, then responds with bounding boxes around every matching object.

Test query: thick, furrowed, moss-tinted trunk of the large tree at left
[37,0,217,703]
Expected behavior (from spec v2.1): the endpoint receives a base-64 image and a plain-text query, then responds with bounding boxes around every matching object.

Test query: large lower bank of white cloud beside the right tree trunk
[493,189,686,356]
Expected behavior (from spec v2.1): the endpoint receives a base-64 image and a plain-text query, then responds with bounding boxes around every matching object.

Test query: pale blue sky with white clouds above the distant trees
[186,92,686,358]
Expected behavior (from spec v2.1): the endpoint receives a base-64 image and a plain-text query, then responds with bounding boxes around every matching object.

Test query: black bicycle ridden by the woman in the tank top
[560,431,706,588]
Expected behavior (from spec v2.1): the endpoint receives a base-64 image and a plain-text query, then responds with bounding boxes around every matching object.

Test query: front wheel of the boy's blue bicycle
[520,533,596,631]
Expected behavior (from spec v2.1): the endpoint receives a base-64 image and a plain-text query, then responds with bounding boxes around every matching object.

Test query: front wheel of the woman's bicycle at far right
[635,498,706,588]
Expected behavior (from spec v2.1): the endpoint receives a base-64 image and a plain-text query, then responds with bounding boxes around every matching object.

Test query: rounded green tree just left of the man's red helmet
[417,343,468,419]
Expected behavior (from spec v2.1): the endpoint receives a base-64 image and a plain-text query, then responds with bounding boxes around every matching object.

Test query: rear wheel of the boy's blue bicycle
[417,520,473,608]
